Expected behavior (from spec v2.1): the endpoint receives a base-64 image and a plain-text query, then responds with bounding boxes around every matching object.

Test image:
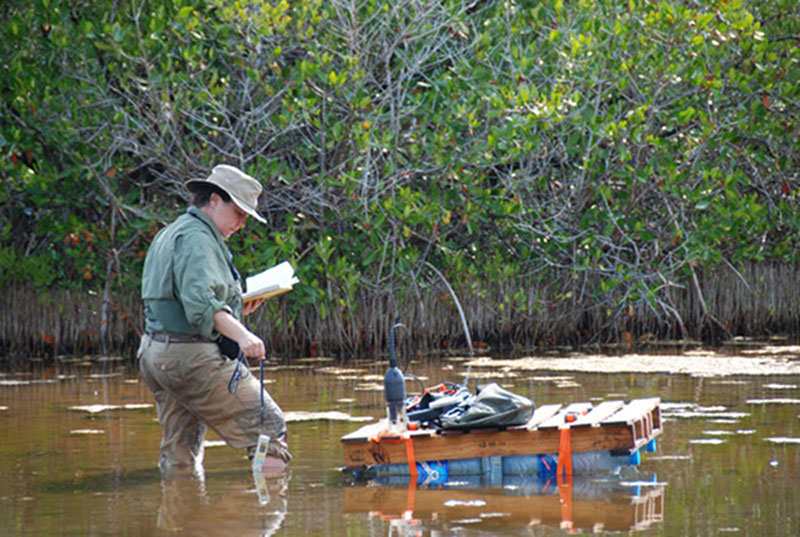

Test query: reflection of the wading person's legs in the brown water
[157,466,290,537]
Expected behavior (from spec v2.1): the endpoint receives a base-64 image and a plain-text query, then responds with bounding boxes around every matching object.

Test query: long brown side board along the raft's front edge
[342,424,635,467]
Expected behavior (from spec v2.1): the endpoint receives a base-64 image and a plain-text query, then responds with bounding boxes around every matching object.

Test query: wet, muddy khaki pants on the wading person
[139,334,291,471]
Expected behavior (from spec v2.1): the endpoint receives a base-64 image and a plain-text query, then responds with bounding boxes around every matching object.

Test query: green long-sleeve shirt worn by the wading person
[142,207,242,338]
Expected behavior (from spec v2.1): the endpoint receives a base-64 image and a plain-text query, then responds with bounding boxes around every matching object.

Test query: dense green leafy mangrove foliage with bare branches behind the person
[0,0,800,348]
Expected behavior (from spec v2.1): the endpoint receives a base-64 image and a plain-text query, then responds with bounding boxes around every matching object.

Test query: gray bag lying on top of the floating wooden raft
[440,382,534,429]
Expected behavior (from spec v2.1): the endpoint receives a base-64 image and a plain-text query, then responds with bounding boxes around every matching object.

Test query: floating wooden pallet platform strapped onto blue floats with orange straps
[341,397,662,482]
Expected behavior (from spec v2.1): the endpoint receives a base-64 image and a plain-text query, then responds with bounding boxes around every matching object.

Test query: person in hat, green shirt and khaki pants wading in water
[139,165,291,473]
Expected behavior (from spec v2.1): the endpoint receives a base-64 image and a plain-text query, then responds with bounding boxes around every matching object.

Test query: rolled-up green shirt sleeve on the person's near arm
[173,228,233,338]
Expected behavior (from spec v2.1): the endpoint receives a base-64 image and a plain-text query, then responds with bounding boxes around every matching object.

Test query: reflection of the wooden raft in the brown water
[344,474,666,535]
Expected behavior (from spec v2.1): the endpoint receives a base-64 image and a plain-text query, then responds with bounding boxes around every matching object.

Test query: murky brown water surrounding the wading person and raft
[0,350,800,537]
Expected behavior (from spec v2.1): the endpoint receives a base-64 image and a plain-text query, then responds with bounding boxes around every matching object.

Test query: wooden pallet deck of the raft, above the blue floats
[341,398,661,467]
